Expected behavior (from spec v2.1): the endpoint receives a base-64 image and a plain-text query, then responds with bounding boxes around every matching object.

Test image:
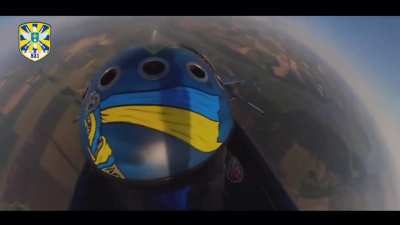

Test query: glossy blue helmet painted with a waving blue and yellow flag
[80,46,233,184]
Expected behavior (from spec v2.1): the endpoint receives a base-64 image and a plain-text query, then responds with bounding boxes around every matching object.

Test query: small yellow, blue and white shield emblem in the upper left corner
[18,22,51,62]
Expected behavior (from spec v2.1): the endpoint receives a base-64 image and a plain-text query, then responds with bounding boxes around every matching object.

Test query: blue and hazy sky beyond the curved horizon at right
[279,16,400,209]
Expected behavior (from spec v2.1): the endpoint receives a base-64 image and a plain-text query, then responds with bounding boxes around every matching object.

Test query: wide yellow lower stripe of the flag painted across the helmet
[101,105,222,152]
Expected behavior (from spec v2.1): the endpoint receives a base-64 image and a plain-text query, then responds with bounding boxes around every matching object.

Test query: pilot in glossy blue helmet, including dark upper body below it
[71,45,234,210]
